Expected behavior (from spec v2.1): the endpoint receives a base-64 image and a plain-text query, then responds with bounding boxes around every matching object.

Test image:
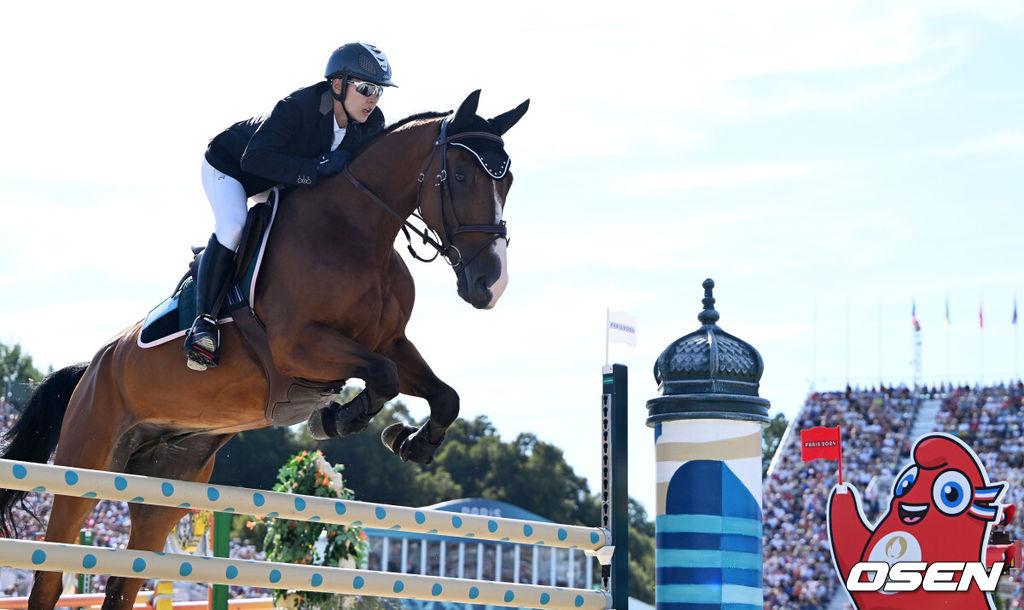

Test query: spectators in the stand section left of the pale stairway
[762,387,920,610]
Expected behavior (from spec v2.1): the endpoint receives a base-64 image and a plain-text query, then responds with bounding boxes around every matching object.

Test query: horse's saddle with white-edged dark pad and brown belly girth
[137,189,345,426]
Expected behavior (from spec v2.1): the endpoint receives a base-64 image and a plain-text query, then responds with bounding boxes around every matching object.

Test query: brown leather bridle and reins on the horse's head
[342,118,508,273]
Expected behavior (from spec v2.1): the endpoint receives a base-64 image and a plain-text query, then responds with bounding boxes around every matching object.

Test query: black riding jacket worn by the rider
[206,81,384,197]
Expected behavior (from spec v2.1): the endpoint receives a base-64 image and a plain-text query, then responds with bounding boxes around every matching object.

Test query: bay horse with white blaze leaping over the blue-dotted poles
[0,91,529,610]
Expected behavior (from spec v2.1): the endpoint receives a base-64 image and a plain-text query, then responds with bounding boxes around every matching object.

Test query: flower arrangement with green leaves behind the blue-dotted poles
[263,450,369,610]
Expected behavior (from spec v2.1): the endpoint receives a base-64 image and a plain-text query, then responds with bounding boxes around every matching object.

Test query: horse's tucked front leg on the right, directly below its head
[381,337,459,464]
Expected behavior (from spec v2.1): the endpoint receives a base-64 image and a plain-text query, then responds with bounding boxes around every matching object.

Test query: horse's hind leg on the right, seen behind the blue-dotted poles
[103,434,233,610]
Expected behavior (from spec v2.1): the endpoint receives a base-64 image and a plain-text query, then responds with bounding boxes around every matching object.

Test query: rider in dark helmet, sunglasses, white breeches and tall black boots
[183,42,396,371]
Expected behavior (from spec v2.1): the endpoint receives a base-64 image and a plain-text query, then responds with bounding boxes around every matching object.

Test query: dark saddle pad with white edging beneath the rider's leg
[138,193,279,348]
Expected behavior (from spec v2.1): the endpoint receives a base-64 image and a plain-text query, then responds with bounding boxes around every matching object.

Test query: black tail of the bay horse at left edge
[0,362,89,537]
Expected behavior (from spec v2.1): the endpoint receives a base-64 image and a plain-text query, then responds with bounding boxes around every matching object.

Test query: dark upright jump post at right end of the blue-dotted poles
[601,364,630,610]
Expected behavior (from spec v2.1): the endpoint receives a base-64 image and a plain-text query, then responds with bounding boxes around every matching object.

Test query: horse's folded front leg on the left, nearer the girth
[300,335,398,440]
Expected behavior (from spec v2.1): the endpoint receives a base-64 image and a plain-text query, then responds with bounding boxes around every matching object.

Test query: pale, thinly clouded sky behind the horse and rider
[0,0,1024,521]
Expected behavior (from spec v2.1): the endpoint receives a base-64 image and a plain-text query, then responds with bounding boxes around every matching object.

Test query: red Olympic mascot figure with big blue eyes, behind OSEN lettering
[828,433,1007,610]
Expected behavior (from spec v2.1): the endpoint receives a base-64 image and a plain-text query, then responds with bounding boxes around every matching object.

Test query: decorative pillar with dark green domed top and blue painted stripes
[647,279,769,610]
